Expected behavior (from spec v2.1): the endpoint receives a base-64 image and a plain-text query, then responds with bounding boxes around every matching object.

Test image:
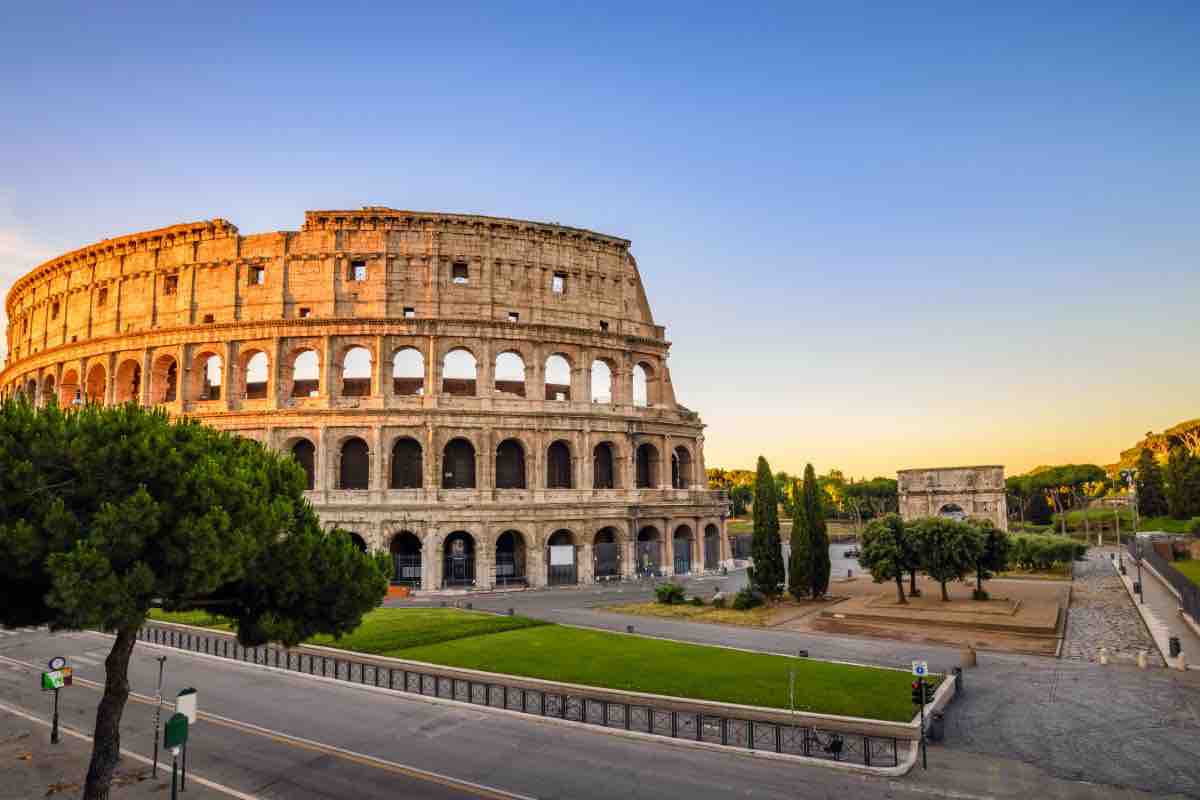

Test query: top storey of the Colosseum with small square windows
[6,207,665,361]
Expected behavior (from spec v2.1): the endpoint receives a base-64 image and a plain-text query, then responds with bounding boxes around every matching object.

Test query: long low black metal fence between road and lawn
[138,625,900,768]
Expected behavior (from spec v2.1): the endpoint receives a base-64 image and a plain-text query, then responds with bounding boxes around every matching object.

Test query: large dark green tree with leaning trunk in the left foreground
[0,401,388,800]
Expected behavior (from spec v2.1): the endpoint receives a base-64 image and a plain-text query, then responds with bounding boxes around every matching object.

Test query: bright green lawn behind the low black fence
[152,608,913,721]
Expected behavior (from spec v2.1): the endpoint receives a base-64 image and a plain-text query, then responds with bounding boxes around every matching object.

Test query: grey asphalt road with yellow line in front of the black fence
[0,631,1195,800]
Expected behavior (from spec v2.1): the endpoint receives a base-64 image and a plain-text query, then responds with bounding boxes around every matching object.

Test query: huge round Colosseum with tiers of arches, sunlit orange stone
[0,206,728,590]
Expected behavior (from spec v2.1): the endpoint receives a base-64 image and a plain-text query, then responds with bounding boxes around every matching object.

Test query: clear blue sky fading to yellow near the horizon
[0,0,1200,476]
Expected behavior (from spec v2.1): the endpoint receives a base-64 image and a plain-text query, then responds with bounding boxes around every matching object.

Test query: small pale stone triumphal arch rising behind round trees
[896,465,1008,530]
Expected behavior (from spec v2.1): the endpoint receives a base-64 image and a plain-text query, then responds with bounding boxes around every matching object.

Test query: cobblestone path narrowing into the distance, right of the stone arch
[1062,548,1163,667]
